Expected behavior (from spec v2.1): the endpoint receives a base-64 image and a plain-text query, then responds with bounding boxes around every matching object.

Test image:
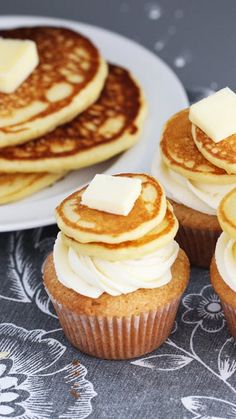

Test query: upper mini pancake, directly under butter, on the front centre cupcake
[56,173,166,244]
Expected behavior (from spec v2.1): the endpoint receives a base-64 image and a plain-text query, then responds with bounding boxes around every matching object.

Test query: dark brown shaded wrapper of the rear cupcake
[175,224,222,268]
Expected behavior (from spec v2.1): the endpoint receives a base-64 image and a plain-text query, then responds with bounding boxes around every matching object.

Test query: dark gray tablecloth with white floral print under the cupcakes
[0,226,236,419]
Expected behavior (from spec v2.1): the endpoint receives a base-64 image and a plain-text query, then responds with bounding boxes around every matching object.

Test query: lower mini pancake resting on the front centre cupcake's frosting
[62,203,178,261]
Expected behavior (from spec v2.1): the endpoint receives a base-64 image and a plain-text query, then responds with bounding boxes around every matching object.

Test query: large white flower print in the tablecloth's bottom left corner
[0,324,96,419]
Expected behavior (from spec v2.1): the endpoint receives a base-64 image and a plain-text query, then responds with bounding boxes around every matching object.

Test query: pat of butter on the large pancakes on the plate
[0,38,39,93]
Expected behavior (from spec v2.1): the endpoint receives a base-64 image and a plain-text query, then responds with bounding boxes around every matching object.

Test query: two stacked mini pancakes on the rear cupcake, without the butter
[161,109,236,185]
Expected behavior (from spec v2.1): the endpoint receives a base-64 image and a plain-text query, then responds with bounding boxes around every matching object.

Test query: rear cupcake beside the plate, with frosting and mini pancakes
[152,89,236,268]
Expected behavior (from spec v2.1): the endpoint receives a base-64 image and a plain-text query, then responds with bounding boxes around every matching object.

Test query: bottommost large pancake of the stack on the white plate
[0,173,65,204]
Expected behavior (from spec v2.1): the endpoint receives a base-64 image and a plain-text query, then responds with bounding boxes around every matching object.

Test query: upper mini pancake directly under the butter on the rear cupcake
[192,125,236,174]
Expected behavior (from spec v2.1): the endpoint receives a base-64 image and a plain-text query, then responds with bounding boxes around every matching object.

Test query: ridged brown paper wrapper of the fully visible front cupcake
[48,298,180,359]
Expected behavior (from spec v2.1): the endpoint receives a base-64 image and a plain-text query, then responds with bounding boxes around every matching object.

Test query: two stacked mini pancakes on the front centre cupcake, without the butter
[56,174,178,261]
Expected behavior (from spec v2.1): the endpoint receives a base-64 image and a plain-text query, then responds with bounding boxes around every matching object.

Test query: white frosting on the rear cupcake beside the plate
[152,153,236,215]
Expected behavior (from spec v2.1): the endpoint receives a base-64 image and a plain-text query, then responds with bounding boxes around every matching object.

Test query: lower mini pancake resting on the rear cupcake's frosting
[160,109,236,184]
